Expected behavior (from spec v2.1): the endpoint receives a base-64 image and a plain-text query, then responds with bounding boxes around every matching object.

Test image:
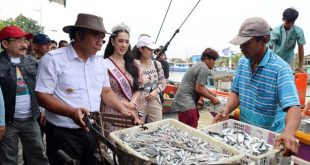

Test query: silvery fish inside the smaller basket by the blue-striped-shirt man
[203,128,273,156]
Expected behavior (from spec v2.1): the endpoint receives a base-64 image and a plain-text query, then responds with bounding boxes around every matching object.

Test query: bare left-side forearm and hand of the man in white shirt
[36,92,90,129]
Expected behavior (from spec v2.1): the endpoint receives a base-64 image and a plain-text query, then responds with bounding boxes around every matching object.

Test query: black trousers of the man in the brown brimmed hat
[45,122,97,165]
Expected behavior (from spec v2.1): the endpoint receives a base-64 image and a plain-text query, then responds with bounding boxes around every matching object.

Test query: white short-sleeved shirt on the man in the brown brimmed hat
[35,44,110,128]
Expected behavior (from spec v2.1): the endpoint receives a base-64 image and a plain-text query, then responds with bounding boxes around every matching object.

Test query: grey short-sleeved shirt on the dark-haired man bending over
[172,62,210,112]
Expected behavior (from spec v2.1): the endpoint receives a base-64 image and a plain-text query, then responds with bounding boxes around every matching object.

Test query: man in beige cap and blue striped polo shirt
[213,17,300,155]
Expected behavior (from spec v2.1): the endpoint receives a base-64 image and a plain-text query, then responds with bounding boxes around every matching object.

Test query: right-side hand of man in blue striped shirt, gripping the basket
[274,131,299,156]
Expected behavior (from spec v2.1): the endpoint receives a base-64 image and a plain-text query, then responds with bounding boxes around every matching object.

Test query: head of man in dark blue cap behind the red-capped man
[32,33,51,60]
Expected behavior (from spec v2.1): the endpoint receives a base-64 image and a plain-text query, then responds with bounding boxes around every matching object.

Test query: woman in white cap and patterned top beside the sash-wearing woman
[133,34,166,123]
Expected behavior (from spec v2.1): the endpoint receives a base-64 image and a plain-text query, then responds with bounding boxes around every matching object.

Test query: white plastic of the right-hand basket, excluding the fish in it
[201,119,280,165]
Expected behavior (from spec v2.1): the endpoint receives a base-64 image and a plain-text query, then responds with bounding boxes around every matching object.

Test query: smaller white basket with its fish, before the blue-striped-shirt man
[201,119,280,165]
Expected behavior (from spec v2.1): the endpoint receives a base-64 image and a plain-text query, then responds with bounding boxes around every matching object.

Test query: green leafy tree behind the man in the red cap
[0,14,44,34]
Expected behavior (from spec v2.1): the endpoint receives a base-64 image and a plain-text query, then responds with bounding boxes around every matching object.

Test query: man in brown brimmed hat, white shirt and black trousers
[36,14,140,165]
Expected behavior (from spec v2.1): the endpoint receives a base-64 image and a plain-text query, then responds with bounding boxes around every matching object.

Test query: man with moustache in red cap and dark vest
[0,26,48,164]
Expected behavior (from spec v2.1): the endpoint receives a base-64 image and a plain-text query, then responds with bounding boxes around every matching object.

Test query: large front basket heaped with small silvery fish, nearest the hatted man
[110,119,244,165]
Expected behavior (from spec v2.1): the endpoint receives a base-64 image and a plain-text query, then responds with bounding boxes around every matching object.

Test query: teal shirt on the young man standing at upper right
[268,25,306,63]
